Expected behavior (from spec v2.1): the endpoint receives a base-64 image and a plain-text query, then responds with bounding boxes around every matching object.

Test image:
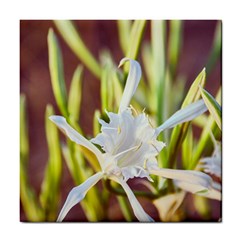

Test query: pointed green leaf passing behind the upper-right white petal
[165,69,206,167]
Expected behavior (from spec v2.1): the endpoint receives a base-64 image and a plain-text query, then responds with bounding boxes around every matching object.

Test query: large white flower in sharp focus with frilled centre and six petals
[50,58,212,222]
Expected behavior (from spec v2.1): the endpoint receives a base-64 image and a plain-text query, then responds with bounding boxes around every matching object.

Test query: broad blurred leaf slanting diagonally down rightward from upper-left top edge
[54,20,101,79]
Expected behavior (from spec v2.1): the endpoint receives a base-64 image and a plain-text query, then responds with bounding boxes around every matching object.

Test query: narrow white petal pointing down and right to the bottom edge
[111,176,154,222]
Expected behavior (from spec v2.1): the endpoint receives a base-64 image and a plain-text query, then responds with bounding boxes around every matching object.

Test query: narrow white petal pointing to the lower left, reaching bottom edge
[57,172,104,222]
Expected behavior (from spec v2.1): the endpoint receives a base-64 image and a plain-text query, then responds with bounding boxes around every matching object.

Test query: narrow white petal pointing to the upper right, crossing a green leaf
[156,100,207,135]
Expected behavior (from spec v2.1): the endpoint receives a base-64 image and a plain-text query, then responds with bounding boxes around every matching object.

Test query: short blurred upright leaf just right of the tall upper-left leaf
[68,65,83,122]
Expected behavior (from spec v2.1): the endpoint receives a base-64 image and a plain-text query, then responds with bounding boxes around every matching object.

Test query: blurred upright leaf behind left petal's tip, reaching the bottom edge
[40,105,62,221]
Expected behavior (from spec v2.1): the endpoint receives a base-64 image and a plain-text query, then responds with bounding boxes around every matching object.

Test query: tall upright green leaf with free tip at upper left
[48,29,68,117]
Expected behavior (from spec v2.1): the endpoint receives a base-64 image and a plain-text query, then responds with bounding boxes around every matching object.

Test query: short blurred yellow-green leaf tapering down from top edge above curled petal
[117,20,131,56]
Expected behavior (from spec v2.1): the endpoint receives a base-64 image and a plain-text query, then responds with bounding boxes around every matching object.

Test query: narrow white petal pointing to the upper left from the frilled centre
[49,115,104,167]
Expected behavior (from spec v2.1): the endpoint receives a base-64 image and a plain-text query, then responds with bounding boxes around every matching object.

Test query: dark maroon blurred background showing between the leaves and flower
[20,20,221,221]
